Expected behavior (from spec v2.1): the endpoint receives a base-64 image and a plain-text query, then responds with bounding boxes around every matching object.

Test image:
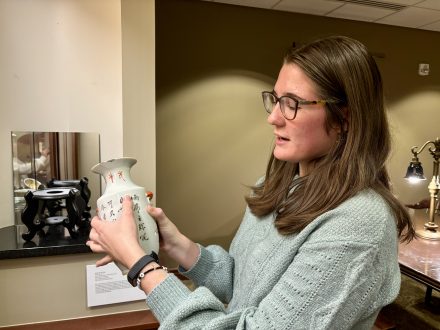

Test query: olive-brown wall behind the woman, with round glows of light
[156,0,440,260]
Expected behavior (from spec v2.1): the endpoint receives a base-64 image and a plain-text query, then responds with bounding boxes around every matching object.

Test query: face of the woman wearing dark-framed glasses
[267,64,338,176]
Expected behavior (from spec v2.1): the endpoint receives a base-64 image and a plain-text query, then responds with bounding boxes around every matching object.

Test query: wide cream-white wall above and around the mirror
[0,0,123,227]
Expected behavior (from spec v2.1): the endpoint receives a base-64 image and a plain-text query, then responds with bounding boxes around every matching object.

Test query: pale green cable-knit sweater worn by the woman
[147,190,400,330]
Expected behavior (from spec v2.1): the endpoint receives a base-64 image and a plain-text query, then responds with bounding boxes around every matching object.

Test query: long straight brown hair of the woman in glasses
[246,36,414,241]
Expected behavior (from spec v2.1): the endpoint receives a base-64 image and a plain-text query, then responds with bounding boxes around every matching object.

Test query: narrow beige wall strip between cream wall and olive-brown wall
[122,0,156,201]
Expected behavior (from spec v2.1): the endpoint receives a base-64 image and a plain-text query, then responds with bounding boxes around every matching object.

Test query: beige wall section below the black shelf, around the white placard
[0,253,146,327]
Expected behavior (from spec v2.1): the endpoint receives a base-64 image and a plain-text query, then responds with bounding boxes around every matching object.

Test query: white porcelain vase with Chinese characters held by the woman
[92,157,159,274]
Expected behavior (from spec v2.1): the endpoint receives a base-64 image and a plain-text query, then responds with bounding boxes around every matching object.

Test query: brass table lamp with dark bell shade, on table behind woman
[405,138,440,240]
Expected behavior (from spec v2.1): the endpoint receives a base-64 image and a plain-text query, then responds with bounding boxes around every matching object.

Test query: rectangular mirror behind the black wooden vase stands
[11,132,101,225]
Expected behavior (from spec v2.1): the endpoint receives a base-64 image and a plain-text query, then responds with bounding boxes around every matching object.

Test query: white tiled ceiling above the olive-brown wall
[204,0,440,32]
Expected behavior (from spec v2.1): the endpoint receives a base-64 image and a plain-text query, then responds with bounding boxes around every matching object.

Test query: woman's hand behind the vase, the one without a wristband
[147,205,200,269]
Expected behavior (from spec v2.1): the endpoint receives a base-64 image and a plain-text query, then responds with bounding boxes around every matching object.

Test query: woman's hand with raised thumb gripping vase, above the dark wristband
[87,196,145,268]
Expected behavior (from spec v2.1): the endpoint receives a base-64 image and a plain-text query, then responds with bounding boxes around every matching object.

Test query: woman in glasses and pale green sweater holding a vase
[88,37,414,329]
